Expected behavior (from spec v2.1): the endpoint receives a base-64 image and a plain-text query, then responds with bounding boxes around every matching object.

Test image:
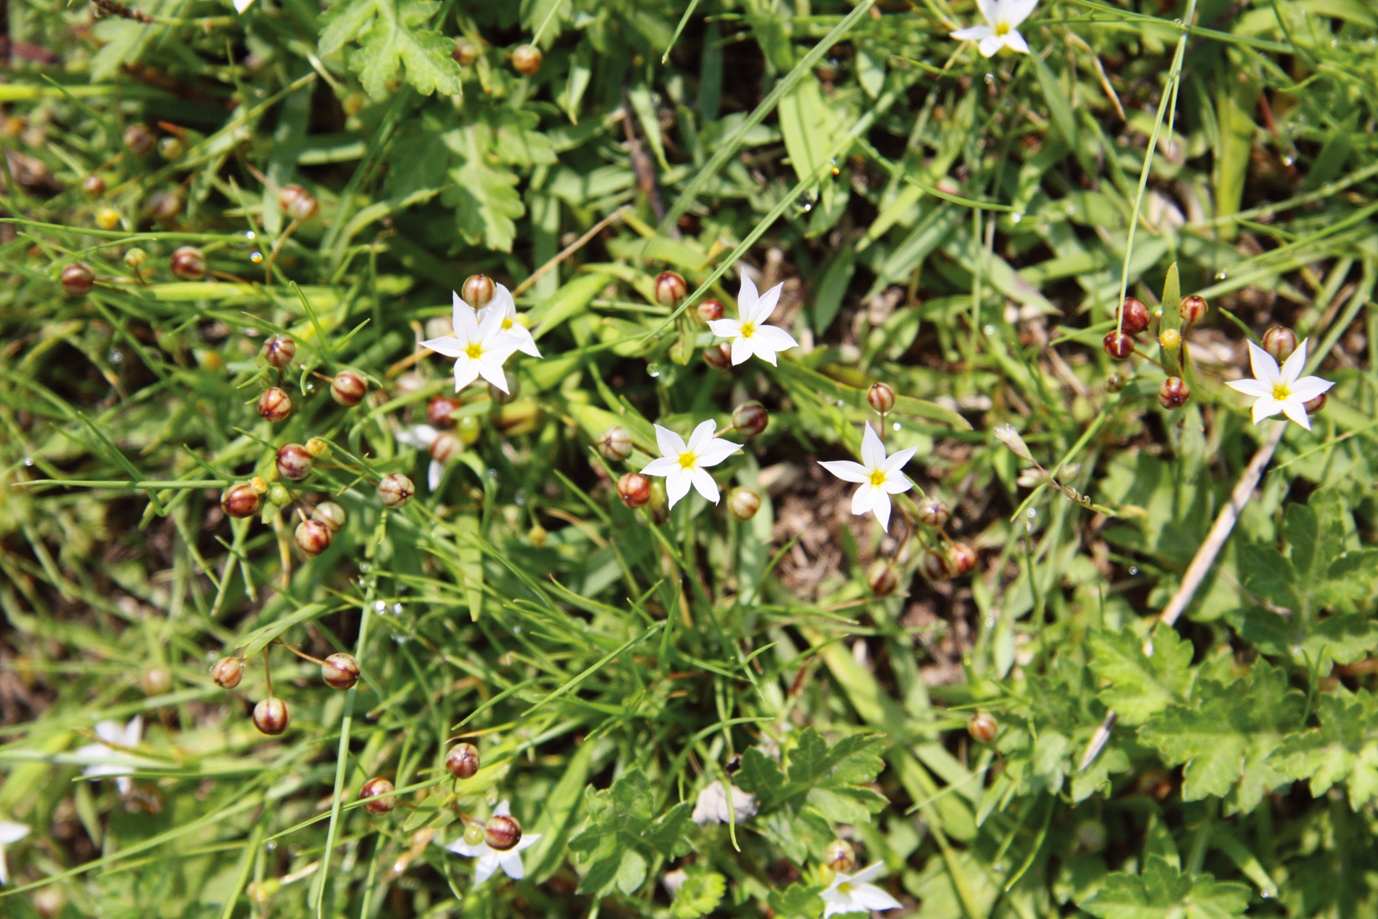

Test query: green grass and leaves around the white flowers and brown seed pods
[0,0,1378,919]
